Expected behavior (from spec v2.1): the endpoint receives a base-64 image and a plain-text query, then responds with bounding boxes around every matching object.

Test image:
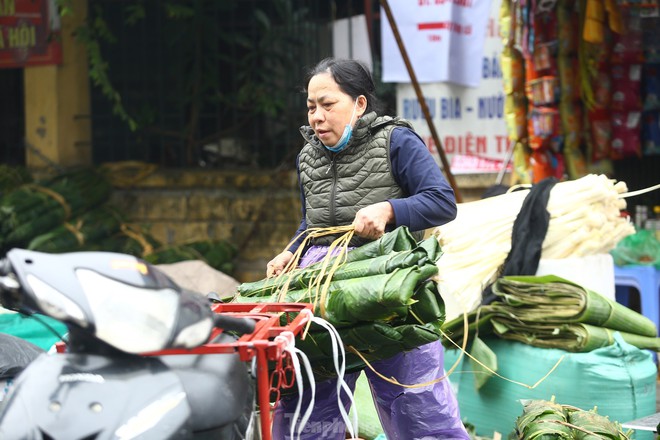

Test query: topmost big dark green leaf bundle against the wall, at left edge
[0,169,111,250]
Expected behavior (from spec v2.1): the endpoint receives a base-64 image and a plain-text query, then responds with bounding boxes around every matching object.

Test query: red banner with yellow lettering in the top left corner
[0,0,62,68]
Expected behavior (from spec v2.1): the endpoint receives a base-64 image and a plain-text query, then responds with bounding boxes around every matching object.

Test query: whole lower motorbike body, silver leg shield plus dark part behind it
[0,346,254,440]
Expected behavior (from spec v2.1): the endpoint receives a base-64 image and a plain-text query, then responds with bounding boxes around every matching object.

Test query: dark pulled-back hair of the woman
[305,58,382,113]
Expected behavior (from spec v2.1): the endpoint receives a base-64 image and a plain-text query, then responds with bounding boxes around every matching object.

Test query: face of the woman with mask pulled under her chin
[307,72,367,146]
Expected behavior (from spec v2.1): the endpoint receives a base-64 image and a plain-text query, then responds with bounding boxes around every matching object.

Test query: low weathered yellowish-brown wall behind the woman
[112,169,502,282]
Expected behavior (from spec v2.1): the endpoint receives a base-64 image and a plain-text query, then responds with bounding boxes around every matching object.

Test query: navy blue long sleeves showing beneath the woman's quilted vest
[289,127,456,252]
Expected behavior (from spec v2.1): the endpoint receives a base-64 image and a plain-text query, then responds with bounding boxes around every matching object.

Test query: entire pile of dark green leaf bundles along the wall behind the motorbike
[0,168,237,274]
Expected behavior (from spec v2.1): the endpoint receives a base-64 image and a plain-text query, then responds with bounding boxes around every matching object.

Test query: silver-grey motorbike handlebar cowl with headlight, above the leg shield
[4,249,213,354]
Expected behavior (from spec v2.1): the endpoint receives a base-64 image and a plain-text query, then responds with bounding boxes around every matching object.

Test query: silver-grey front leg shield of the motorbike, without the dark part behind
[0,348,191,440]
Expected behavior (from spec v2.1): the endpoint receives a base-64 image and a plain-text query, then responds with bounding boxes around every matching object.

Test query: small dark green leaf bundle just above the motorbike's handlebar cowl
[28,205,124,253]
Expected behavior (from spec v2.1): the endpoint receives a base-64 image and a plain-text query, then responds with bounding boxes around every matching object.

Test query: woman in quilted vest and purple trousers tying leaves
[266,58,469,440]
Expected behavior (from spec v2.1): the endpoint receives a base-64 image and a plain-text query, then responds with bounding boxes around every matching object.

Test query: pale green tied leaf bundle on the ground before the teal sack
[516,400,630,440]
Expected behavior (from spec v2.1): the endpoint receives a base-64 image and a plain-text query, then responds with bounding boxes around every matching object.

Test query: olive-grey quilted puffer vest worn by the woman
[298,112,424,246]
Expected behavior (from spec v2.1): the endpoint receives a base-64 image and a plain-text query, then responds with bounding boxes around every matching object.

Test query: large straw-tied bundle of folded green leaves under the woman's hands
[233,227,444,378]
